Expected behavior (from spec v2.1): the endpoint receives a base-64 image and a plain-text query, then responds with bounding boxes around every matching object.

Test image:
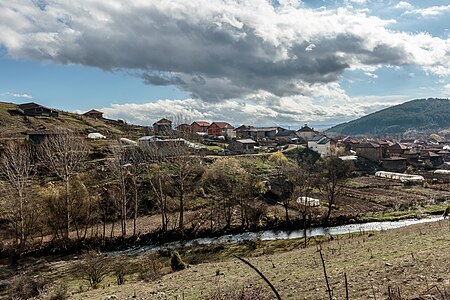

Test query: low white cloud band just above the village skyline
[99,89,407,127]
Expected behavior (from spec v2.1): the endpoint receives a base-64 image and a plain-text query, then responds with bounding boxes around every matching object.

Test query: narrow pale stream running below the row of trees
[115,216,443,256]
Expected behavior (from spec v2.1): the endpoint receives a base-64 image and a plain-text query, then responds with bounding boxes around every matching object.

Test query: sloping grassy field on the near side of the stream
[0,220,450,299]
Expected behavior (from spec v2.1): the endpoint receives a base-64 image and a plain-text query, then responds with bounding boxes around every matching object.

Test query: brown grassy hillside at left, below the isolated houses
[0,102,145,139]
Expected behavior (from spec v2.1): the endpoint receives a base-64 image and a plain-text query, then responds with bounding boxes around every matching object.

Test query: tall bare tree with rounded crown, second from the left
[38,131,88,241]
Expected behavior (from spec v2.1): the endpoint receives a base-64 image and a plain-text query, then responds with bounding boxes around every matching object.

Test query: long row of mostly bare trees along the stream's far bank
[0,132,348,262]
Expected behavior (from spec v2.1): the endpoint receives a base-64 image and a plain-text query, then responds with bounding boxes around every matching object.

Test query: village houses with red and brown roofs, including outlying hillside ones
[13,103,450,172]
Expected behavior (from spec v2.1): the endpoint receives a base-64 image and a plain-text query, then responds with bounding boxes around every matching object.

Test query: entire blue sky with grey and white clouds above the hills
[0,0,450,127]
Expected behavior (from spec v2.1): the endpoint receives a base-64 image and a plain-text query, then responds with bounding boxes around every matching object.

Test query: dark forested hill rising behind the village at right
[326,98,450,135]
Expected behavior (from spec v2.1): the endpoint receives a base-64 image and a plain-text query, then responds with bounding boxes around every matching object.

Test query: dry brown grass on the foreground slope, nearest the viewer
[33,220,444,299]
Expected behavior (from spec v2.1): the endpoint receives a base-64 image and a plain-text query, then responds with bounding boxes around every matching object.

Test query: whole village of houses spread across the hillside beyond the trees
[17,103,450,174]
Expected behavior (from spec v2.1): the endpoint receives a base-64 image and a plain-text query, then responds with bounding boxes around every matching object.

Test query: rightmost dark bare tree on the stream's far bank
[321,157,351,223]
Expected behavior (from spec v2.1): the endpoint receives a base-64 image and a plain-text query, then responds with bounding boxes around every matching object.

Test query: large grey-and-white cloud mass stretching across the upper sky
[0,0,450,102]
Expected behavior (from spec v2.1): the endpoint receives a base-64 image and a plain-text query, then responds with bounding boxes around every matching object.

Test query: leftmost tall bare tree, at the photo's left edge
[0,142,41,262]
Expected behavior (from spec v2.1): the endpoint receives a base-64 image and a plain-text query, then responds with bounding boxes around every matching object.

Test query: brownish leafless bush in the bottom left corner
[8,274,49,299]
